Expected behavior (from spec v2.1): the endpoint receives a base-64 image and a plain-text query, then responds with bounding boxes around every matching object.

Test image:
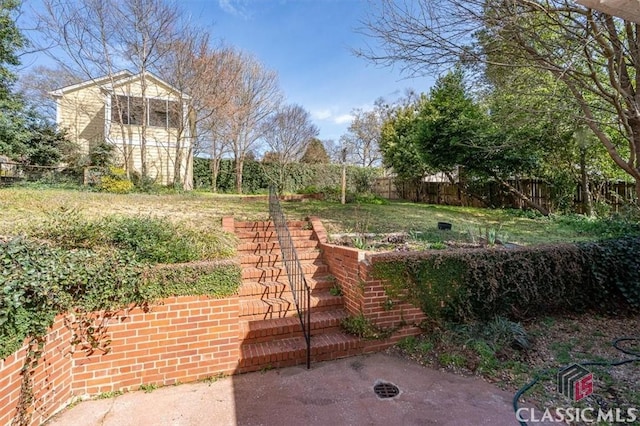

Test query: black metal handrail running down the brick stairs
[269,186,311,368]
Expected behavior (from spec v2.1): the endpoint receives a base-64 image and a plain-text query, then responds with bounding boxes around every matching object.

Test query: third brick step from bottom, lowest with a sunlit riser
[240,290,343,321]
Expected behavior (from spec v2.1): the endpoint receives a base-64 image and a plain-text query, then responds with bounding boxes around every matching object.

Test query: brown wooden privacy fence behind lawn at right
[372,177,635,211]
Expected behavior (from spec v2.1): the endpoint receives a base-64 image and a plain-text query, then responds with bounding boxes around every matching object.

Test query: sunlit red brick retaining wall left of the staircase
[0,297,240,425]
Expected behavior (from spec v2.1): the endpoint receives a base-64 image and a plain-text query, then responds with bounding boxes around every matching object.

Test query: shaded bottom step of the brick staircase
[237,332,363,373]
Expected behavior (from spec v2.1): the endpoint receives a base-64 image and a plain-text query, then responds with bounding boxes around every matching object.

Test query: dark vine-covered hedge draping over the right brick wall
[371,237,640,322]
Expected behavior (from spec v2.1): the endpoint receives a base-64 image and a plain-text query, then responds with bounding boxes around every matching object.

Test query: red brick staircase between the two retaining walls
[234,221,360,373]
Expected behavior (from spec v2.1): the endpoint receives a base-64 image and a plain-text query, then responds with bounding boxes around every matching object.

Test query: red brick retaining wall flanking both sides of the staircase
[0,218,425,425]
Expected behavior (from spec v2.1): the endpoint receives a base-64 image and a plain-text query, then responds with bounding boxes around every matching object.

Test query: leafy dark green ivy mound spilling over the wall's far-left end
[0,238,141,358]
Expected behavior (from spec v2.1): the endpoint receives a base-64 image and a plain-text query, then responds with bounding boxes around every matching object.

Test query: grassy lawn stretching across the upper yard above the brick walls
[0,187,628,245]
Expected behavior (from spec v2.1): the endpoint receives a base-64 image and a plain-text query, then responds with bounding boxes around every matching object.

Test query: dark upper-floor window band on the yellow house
[111,95,180,128]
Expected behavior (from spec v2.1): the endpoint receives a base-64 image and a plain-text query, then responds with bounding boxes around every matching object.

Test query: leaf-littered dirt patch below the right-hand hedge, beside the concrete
[390,314,640,422]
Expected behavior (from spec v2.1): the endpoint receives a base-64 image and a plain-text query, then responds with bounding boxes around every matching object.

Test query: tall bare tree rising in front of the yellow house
[36,0,182,181]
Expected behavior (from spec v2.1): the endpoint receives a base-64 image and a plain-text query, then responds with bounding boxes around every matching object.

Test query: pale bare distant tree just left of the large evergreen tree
[341,99,384,167]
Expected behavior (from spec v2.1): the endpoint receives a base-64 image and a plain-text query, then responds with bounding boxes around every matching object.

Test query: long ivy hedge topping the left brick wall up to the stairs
[0,238,240,359]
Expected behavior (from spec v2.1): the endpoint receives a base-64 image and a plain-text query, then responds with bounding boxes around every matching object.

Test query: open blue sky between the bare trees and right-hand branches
[17,0,433,142]
